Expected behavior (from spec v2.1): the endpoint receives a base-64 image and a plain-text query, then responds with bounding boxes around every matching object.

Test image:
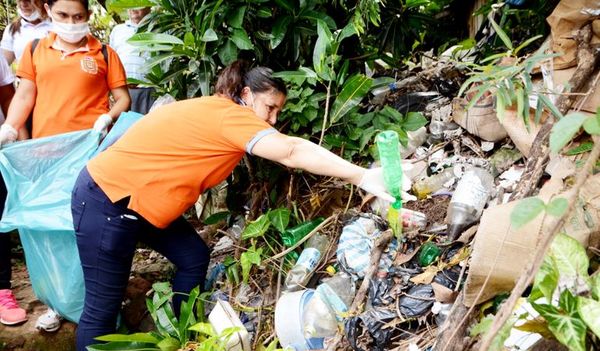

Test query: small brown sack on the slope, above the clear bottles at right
[452,96,508,141]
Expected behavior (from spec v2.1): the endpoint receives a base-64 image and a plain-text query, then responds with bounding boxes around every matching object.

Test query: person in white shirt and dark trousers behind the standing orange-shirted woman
[109,7,155,115]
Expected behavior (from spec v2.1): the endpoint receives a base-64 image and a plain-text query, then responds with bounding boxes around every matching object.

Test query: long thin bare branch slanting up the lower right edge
[480,136,600,350]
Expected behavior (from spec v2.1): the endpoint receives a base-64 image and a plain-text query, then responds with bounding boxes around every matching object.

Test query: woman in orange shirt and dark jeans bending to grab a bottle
[71,61,394,351]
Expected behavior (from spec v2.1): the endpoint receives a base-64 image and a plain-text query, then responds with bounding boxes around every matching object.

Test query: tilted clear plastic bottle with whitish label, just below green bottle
[285,233,329,291]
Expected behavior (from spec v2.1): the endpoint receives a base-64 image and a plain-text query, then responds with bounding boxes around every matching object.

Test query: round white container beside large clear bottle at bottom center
[275,289,323,351]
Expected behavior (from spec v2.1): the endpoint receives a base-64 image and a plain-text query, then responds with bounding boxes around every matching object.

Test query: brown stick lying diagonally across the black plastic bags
[327,229,394,351]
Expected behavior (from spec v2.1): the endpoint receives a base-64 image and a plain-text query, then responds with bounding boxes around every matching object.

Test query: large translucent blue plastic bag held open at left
[0,112,142,323]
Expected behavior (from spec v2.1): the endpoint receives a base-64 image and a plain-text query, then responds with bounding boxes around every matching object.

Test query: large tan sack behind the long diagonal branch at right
[465,175,600,306]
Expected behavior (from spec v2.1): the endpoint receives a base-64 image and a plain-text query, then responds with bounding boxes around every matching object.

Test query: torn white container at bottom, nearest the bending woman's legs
[208,300,250,351]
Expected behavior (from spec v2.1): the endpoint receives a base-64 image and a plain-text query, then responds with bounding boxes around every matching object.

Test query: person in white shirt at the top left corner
[0,0,51,65]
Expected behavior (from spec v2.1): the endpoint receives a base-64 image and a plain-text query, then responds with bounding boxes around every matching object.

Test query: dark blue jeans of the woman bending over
[71,168,210,351]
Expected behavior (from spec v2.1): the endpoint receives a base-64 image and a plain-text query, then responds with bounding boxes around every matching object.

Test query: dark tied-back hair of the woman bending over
[215,60,287,99]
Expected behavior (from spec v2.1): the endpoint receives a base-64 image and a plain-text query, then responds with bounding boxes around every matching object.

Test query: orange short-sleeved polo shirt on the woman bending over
[87,96,277,228]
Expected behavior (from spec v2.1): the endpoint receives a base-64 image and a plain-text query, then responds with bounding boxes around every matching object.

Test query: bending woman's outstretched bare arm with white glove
[252,133,410,202]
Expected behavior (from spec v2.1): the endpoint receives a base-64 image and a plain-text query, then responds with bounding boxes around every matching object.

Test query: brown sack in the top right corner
[546,0,600,69]
